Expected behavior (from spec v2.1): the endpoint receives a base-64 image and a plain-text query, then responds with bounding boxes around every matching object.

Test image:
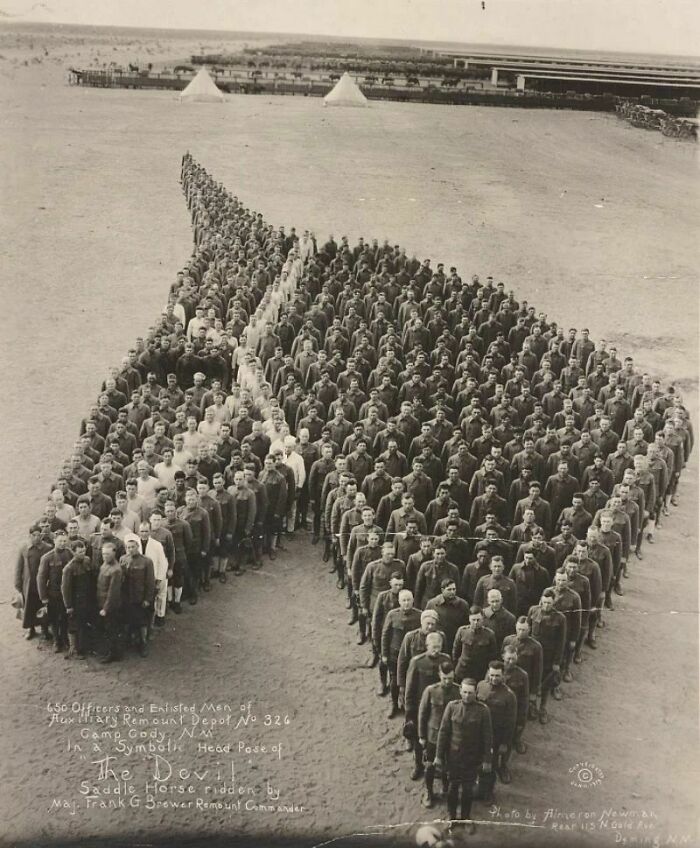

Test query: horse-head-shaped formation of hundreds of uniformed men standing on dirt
[15,154,693,819]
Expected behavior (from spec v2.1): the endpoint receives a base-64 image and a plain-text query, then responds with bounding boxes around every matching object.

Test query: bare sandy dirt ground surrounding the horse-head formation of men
[0,24,699,846]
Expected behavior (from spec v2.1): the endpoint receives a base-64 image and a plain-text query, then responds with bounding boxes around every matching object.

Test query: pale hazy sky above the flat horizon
[0,0,700,55]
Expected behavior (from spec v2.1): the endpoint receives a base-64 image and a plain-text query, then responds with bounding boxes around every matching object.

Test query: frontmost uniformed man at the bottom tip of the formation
[433,678,493,833]
